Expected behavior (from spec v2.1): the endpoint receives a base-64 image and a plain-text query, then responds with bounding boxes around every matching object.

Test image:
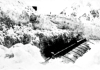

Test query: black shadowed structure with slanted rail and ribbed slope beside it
[40,34,89,62]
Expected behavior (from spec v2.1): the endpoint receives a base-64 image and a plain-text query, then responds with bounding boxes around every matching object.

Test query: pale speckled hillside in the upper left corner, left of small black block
[0,0,35,23]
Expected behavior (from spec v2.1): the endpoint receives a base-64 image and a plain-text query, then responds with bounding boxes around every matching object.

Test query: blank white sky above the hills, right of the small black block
[25,0,100,14]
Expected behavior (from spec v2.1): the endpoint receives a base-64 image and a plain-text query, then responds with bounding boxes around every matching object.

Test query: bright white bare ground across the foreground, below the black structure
[0,41,100,70]
